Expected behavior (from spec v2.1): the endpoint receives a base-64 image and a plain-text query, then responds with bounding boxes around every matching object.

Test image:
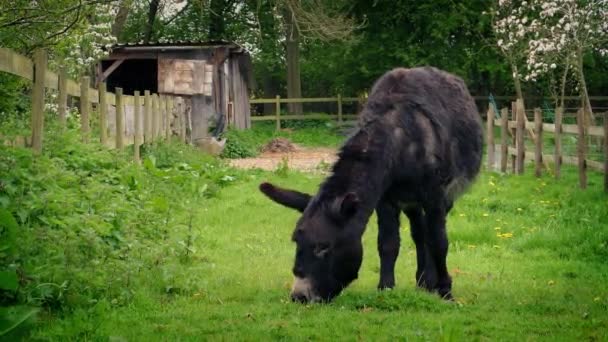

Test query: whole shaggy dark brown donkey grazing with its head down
[260,67,483,302]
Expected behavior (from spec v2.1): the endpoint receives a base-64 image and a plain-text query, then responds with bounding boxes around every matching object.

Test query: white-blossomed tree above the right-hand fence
[491,0,608,112]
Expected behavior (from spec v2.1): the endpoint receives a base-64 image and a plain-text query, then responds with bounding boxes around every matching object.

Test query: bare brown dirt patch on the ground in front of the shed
[230,145,337,173]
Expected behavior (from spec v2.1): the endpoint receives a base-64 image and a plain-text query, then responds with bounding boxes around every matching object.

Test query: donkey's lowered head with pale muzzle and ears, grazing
[260,183,363,303]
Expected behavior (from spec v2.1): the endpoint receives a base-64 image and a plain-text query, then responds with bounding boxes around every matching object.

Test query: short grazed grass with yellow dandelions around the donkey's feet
[33,165,608,341]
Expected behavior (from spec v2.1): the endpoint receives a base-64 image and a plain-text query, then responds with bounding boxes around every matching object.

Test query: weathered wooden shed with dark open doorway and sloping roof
[97,41,252,144]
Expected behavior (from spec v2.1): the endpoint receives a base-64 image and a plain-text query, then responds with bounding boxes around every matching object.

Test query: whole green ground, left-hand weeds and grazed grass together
[0,123,608,341]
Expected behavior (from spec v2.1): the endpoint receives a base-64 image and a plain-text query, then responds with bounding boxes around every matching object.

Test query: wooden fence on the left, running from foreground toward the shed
[0,48,190,161]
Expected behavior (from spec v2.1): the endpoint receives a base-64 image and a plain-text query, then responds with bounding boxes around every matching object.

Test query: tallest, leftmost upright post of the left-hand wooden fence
[31,49,47,154]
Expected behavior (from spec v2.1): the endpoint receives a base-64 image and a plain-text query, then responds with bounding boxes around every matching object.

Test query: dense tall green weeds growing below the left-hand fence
[0,123,241,332]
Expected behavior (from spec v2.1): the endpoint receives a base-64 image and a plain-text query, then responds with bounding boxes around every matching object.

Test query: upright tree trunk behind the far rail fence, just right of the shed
[285,10,302,114]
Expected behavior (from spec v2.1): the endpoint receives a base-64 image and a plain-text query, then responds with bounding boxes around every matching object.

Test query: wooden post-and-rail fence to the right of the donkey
[486,100,608,192]
